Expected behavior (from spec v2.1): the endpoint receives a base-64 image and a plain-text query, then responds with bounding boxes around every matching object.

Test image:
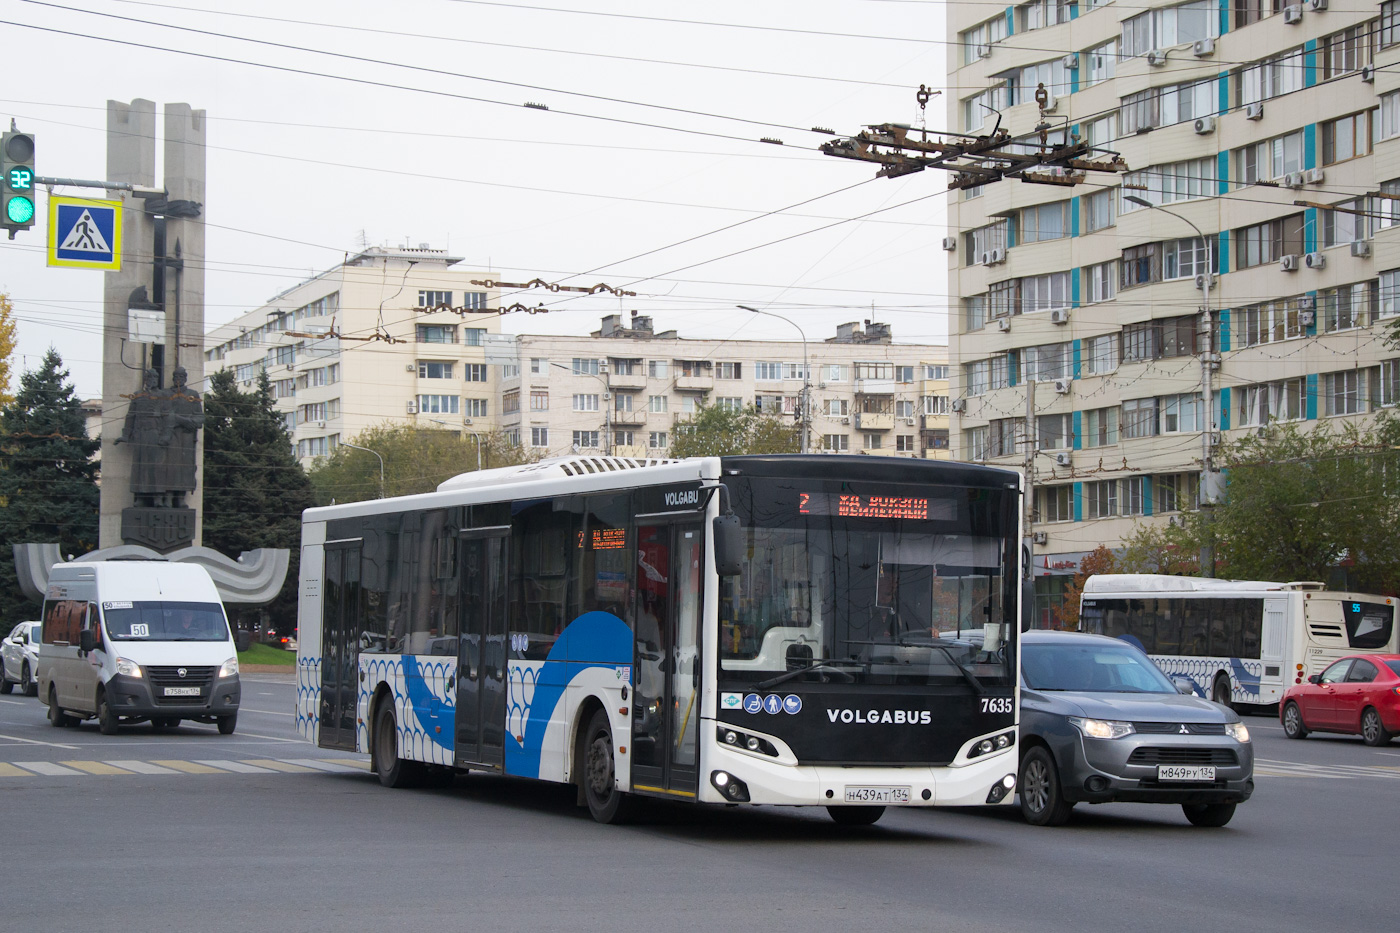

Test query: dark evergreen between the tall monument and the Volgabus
[203,370,315,635]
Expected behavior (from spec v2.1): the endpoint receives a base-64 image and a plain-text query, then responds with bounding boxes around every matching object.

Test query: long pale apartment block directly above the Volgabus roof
[500,314,948,458]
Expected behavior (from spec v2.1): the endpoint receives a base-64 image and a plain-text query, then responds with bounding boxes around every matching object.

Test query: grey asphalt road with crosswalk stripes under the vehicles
[0,674,1400,933]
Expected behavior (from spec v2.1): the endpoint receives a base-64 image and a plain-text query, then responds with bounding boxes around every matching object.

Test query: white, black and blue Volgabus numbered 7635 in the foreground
[297,455,1021,824]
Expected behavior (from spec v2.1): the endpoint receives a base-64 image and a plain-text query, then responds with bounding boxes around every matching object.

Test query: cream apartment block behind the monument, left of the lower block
[204,247,498,465]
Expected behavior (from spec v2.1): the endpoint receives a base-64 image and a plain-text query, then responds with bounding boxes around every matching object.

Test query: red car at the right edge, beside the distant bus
[1278,654,1400,745]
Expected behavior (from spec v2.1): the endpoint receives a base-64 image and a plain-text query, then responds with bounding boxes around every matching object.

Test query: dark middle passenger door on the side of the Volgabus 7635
[452,528,510,769]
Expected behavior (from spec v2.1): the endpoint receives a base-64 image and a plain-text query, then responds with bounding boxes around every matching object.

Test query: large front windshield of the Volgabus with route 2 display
[720,479,1016,689]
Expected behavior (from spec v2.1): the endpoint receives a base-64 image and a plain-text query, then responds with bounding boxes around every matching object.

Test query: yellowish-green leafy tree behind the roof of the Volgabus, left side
[309,422,539,506]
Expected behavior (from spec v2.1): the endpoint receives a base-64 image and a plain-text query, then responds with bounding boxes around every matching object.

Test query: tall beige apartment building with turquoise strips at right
[944,0,1400,622]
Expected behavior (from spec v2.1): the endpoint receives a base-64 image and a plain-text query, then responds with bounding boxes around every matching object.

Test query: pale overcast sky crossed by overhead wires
[0,0,949,398]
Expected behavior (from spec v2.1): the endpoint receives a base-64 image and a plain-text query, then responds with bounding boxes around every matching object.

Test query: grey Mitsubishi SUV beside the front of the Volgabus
[1016,632,1254,827]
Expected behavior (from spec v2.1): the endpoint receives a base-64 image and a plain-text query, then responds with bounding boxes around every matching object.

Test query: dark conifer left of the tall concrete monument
[0,347,98,633]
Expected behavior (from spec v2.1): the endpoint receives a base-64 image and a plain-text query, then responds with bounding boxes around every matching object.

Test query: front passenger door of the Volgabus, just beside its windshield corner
[631,521,704,797]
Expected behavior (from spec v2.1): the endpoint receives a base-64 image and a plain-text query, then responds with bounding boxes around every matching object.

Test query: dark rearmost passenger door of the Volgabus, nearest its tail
[319,541,360,751]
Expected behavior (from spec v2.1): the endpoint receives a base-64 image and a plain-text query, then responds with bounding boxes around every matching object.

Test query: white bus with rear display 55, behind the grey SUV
[1079,573,1397,706]
